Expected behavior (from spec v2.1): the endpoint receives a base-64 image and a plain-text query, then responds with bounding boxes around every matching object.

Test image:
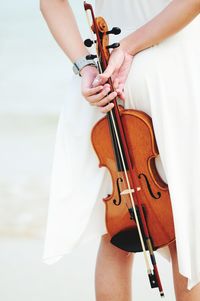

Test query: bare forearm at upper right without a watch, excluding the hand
[121,0,200,55]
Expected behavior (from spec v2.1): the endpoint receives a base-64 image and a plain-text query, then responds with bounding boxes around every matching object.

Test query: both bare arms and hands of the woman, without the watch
[40,0,200,112]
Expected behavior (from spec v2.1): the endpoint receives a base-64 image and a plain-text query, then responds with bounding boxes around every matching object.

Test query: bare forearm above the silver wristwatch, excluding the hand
[40,0,88,62]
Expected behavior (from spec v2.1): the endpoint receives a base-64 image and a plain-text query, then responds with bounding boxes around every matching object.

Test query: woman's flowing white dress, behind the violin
[43,0,200,289]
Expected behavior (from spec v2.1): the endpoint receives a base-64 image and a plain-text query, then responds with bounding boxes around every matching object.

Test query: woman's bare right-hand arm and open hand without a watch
[94,0,200,101]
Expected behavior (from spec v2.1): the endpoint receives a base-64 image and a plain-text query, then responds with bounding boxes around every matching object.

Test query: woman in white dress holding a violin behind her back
[41,0,200,301]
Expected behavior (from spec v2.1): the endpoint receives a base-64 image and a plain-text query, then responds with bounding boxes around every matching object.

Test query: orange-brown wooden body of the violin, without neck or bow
[91,109,175,252]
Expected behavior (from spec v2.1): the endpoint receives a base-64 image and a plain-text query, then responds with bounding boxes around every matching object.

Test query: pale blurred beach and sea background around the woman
[0,0,175,301]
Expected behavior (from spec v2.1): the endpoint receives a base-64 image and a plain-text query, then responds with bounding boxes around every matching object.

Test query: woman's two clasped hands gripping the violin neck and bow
[81,47,133,113]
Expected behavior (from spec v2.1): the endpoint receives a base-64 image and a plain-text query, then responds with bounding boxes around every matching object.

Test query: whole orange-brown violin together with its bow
[84,2,175,297]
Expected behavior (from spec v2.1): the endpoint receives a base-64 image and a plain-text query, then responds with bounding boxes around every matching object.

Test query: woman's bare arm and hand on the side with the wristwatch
[40,0,117,110]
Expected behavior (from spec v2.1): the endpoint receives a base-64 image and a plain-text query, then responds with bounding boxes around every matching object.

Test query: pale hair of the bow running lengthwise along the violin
[85,7,151,274]
